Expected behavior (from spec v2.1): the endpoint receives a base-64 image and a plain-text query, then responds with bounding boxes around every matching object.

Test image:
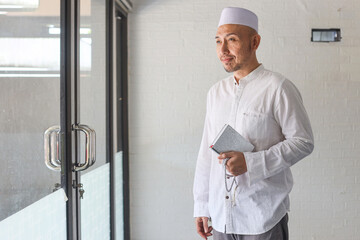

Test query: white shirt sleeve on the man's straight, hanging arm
[193,91,211,217]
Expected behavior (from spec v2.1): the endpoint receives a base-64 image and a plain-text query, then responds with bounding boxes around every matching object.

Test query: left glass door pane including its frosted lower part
[0,0,66,239]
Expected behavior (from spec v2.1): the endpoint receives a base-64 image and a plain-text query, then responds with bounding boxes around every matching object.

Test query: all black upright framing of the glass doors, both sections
[60,0,131,240]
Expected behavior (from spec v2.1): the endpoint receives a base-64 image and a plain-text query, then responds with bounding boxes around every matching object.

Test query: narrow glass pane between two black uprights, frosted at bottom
[80,0,110,237]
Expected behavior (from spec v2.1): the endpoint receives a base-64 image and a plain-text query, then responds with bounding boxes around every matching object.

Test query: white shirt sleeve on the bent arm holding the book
[244,80,314,185]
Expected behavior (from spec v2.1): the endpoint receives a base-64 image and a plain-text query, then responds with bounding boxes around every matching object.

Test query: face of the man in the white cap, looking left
[215,24,257,72]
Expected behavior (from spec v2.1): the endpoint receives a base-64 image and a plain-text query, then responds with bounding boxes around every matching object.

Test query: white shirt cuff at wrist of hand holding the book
[244,151,267,185]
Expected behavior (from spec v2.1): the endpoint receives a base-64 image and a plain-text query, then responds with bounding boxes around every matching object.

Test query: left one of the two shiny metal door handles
[44,126,61,171]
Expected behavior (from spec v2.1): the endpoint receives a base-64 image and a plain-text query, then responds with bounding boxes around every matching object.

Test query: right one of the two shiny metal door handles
[73,124,96,172]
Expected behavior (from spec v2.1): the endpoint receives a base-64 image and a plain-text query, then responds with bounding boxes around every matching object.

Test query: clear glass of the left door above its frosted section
[0,0,65,227]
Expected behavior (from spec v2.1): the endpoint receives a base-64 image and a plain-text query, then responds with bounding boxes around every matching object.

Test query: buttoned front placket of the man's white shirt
[225,80,246,232]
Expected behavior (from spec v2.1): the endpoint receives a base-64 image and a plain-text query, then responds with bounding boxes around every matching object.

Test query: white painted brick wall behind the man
[129,0,360,240]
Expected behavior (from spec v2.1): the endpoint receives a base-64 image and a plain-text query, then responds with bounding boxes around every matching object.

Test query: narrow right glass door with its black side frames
[67,0,126,240]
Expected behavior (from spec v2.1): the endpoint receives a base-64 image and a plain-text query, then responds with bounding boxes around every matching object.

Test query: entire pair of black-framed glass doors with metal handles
[0,0,129,240]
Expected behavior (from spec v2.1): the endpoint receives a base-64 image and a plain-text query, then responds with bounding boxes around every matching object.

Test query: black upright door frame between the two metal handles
[60,0,80,239]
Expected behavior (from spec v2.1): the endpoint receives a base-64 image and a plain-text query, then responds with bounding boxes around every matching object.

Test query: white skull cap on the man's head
[218,7,258,32]
